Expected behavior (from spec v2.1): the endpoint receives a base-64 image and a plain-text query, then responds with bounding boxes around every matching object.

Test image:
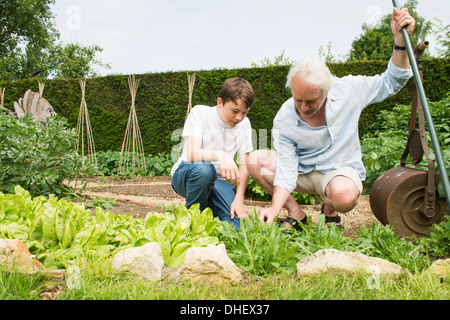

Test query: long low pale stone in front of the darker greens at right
[297,249,403,275]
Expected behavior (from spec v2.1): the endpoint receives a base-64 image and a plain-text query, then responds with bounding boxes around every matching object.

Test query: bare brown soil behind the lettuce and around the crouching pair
[71,177,377,238]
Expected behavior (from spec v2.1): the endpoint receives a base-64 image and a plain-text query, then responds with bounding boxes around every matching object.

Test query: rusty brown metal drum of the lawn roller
[370,167,449,238]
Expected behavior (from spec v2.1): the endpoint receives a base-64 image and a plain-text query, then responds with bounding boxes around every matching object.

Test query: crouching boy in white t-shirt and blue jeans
[171,78,255,230]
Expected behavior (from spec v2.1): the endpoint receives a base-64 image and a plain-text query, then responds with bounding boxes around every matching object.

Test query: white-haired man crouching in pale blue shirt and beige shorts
[247,8,415,231]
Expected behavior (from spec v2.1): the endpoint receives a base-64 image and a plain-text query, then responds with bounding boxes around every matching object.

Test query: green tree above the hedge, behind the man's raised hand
[348,0,432,61]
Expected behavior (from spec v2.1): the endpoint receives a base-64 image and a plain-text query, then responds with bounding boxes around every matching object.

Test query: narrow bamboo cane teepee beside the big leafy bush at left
[76,79,97,166]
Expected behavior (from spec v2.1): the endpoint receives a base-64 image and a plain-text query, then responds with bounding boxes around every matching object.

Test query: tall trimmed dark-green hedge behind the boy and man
[0,59,450,154]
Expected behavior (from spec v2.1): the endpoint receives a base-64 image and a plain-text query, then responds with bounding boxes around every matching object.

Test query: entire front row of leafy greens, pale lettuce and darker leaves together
[0,186,442,275]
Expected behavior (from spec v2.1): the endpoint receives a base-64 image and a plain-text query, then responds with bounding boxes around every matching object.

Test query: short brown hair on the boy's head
[219,78,255,109]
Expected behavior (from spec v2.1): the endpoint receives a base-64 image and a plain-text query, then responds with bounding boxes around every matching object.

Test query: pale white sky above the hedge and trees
[52,0,450,76]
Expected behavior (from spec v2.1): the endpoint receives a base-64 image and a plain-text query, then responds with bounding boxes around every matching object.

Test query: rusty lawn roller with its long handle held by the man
[370,0,450,238]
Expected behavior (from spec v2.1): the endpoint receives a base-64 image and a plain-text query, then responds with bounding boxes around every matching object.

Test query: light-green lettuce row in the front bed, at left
[0,186,219,267]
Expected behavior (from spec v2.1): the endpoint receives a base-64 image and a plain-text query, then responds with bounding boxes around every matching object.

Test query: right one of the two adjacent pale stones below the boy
[178,244,242,285]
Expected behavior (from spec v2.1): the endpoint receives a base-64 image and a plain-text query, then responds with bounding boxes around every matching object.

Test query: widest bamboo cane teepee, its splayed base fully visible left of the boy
[117,75,146,176]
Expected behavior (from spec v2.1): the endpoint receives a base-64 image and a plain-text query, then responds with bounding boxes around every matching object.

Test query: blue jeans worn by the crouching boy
[172,161,239,230]
